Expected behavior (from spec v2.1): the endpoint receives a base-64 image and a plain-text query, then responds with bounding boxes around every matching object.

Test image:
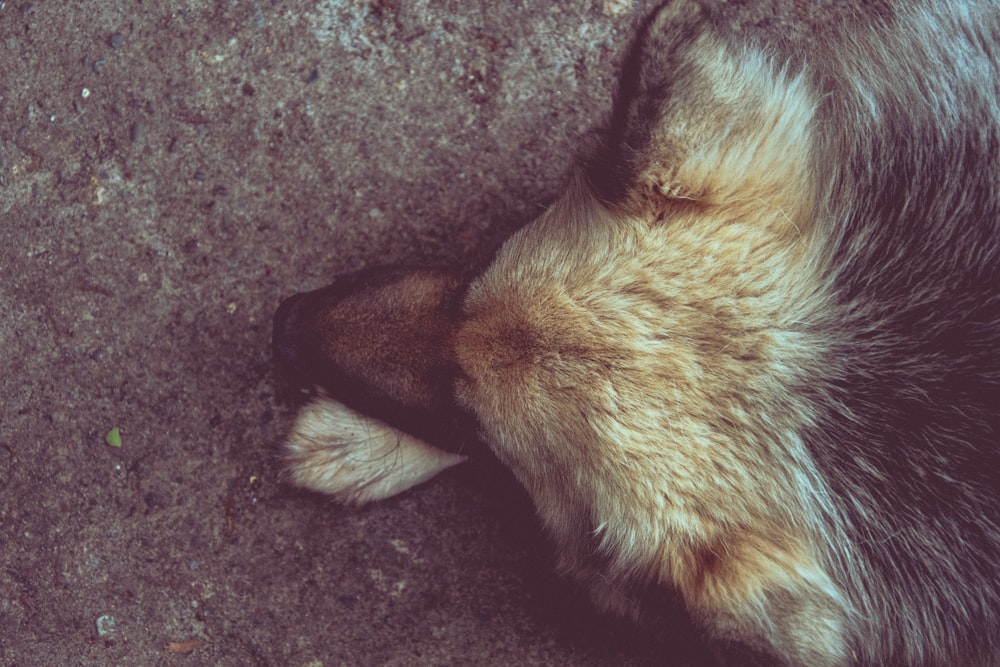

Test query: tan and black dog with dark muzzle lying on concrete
[273,0,1000,667]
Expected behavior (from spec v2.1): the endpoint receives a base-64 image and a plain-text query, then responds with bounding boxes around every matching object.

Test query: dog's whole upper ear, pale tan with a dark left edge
[584,1,816,224]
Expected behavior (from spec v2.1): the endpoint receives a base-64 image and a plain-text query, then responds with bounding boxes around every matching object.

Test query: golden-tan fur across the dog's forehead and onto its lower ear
[455,164,847,665]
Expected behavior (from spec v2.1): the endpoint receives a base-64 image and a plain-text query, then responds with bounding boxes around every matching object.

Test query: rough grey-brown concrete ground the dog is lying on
[0,0,860,667]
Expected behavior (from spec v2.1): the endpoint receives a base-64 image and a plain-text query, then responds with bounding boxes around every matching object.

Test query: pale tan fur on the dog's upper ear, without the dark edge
[627,3,816,235]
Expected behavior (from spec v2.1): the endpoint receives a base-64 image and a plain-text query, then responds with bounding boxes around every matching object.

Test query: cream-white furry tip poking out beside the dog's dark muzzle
[285,398,466,505]
